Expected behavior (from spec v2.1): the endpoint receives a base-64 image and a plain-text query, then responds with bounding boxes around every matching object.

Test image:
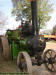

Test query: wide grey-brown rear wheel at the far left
[1,37,9,60]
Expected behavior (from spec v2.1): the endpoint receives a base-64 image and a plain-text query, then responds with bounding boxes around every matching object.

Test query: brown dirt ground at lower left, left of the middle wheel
[0,55,17,72]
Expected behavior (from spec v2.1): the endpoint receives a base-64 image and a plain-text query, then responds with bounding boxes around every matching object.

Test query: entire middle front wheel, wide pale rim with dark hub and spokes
[17,52,32,75]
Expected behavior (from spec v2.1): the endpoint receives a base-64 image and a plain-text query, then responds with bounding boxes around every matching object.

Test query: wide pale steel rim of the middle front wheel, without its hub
[17,52,32,75]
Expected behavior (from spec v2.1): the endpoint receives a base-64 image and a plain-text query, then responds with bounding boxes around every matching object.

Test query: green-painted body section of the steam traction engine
[7,29,30,59]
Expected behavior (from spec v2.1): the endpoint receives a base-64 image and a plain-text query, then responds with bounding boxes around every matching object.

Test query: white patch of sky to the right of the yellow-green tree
[46,0,56,29]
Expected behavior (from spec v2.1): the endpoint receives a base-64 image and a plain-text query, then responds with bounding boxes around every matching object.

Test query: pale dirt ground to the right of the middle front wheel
[33,42,56,75]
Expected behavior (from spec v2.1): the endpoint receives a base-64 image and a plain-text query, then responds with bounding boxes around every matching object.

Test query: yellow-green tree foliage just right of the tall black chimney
[38,0,53,29]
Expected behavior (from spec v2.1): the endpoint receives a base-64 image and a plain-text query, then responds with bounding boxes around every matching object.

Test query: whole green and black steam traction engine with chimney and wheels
[0,0,56,75]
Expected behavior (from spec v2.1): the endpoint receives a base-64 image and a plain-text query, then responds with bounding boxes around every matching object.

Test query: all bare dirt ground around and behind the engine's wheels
[0,42,56,75]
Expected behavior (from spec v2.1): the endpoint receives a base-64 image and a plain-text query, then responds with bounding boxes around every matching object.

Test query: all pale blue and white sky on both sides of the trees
[0,0,56,34]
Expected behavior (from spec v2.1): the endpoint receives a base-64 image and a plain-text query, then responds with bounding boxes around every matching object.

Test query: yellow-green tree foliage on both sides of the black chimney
[13,0,53,29]
